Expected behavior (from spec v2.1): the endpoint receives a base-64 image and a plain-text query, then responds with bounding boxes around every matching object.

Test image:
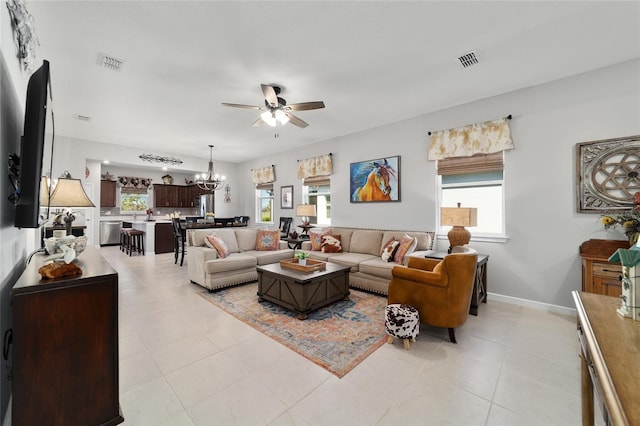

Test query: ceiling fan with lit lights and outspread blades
[222,84,324,129]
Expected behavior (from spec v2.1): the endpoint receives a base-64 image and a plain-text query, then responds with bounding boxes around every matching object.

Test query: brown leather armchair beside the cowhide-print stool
[389,253,478,343]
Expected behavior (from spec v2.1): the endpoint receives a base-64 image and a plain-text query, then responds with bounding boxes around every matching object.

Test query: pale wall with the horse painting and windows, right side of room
[239,60,640,307]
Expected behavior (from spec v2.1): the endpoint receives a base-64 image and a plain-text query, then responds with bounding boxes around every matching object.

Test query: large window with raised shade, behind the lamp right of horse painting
[437,152,505,240]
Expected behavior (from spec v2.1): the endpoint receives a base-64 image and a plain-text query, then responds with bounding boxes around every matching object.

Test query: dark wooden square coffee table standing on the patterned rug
[256,262,350,320]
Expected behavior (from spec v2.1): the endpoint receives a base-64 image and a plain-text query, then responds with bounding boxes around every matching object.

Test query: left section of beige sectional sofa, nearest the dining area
[187,228,293,290]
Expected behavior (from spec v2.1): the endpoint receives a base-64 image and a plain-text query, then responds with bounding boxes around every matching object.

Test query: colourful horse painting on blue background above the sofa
[351,157,399,202]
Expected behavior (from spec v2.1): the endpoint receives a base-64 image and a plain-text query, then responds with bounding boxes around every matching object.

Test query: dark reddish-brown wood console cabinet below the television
[11,246,124,426]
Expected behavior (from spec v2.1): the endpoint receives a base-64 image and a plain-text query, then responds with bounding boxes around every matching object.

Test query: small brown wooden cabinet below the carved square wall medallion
[580,240,629,297]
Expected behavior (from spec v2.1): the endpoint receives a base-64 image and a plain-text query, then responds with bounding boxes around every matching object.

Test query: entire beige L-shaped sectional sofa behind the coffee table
[187,227,435,295]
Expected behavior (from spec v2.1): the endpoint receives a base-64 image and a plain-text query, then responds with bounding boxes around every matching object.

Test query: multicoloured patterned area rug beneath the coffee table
[201,283,387,377]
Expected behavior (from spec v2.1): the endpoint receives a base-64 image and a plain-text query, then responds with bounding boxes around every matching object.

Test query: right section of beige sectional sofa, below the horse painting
[302,227,435,295]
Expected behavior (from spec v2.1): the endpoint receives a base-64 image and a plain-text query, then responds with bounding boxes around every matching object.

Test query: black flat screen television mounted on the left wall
[14,61,49,228]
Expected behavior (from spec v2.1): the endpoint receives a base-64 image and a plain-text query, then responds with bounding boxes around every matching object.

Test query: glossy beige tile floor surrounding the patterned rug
[101,247,580,426]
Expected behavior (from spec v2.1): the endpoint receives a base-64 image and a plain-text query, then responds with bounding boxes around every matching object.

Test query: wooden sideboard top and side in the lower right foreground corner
[573,291,640,426]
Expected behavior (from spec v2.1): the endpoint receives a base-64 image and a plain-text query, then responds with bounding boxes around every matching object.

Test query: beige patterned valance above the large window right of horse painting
[428,118,514,161]
